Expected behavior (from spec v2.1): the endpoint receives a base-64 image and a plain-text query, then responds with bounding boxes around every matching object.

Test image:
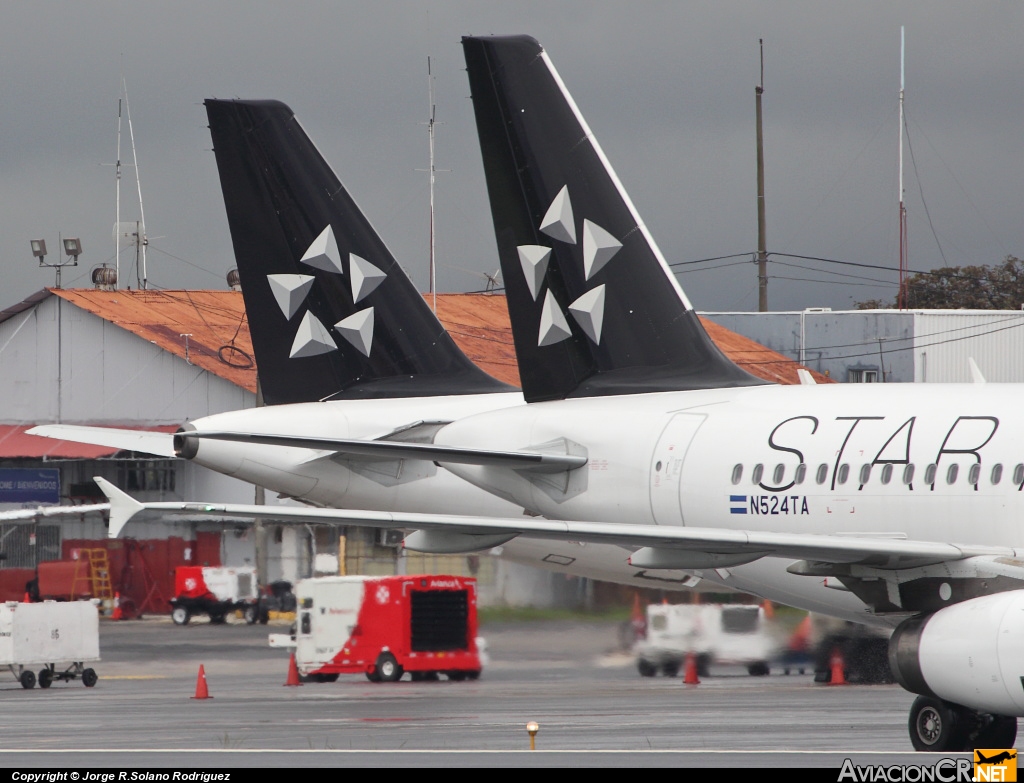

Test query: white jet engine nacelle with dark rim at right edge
[889,590,1024,715]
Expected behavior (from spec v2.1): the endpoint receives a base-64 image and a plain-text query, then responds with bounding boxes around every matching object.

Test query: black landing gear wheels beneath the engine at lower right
[908,696,1017,753]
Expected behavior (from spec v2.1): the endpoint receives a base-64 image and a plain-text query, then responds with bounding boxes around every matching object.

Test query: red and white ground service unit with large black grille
[270,574,482,683]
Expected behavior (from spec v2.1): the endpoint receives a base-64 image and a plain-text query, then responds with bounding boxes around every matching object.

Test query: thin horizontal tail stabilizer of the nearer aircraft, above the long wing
[178,428,587,473]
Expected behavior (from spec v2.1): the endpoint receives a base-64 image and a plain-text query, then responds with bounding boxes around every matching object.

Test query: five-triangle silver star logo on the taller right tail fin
[516,185,623,348]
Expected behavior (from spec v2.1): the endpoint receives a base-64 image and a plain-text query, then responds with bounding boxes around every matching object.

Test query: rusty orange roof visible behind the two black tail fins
[49,289,831,393]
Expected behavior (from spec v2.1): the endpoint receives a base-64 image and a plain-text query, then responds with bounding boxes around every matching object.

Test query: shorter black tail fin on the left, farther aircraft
[206,99,511,404]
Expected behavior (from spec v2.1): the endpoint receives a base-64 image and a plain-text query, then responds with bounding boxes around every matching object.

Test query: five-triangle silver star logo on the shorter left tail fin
[267,225,387,359]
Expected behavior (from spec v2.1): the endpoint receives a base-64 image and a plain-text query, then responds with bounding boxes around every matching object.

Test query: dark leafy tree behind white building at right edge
[857,256,1024,310]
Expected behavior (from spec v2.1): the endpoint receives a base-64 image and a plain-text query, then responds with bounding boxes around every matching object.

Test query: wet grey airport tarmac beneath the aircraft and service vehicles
[0,618,983,779]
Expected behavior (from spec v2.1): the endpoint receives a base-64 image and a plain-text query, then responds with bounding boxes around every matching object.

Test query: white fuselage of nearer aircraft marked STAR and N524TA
[435,385,1024,624]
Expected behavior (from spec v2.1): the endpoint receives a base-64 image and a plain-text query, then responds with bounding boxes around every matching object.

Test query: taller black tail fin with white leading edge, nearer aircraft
[463,36,764,401]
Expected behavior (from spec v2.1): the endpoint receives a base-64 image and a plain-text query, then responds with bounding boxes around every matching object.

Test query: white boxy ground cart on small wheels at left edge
[0,601,99,688]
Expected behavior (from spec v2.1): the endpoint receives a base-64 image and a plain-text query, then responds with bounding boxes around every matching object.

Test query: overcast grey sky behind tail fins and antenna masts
[0,0,1024,310]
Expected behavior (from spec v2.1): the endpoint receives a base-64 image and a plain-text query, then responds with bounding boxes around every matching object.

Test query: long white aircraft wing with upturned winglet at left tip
[95,477,1007,572]
